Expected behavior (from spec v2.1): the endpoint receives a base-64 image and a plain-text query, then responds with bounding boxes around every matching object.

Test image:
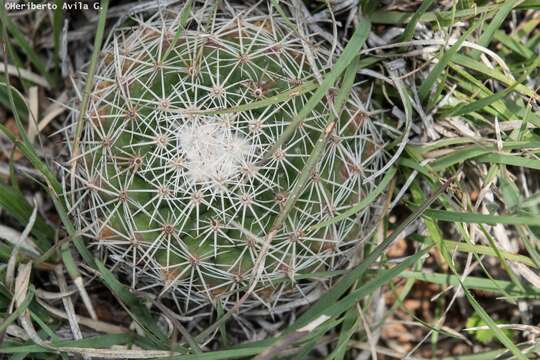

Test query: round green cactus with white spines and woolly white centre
[66,6,388,308]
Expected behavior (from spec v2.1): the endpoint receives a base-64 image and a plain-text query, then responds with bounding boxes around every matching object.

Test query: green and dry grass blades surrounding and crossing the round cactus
[0,0,540,360]
